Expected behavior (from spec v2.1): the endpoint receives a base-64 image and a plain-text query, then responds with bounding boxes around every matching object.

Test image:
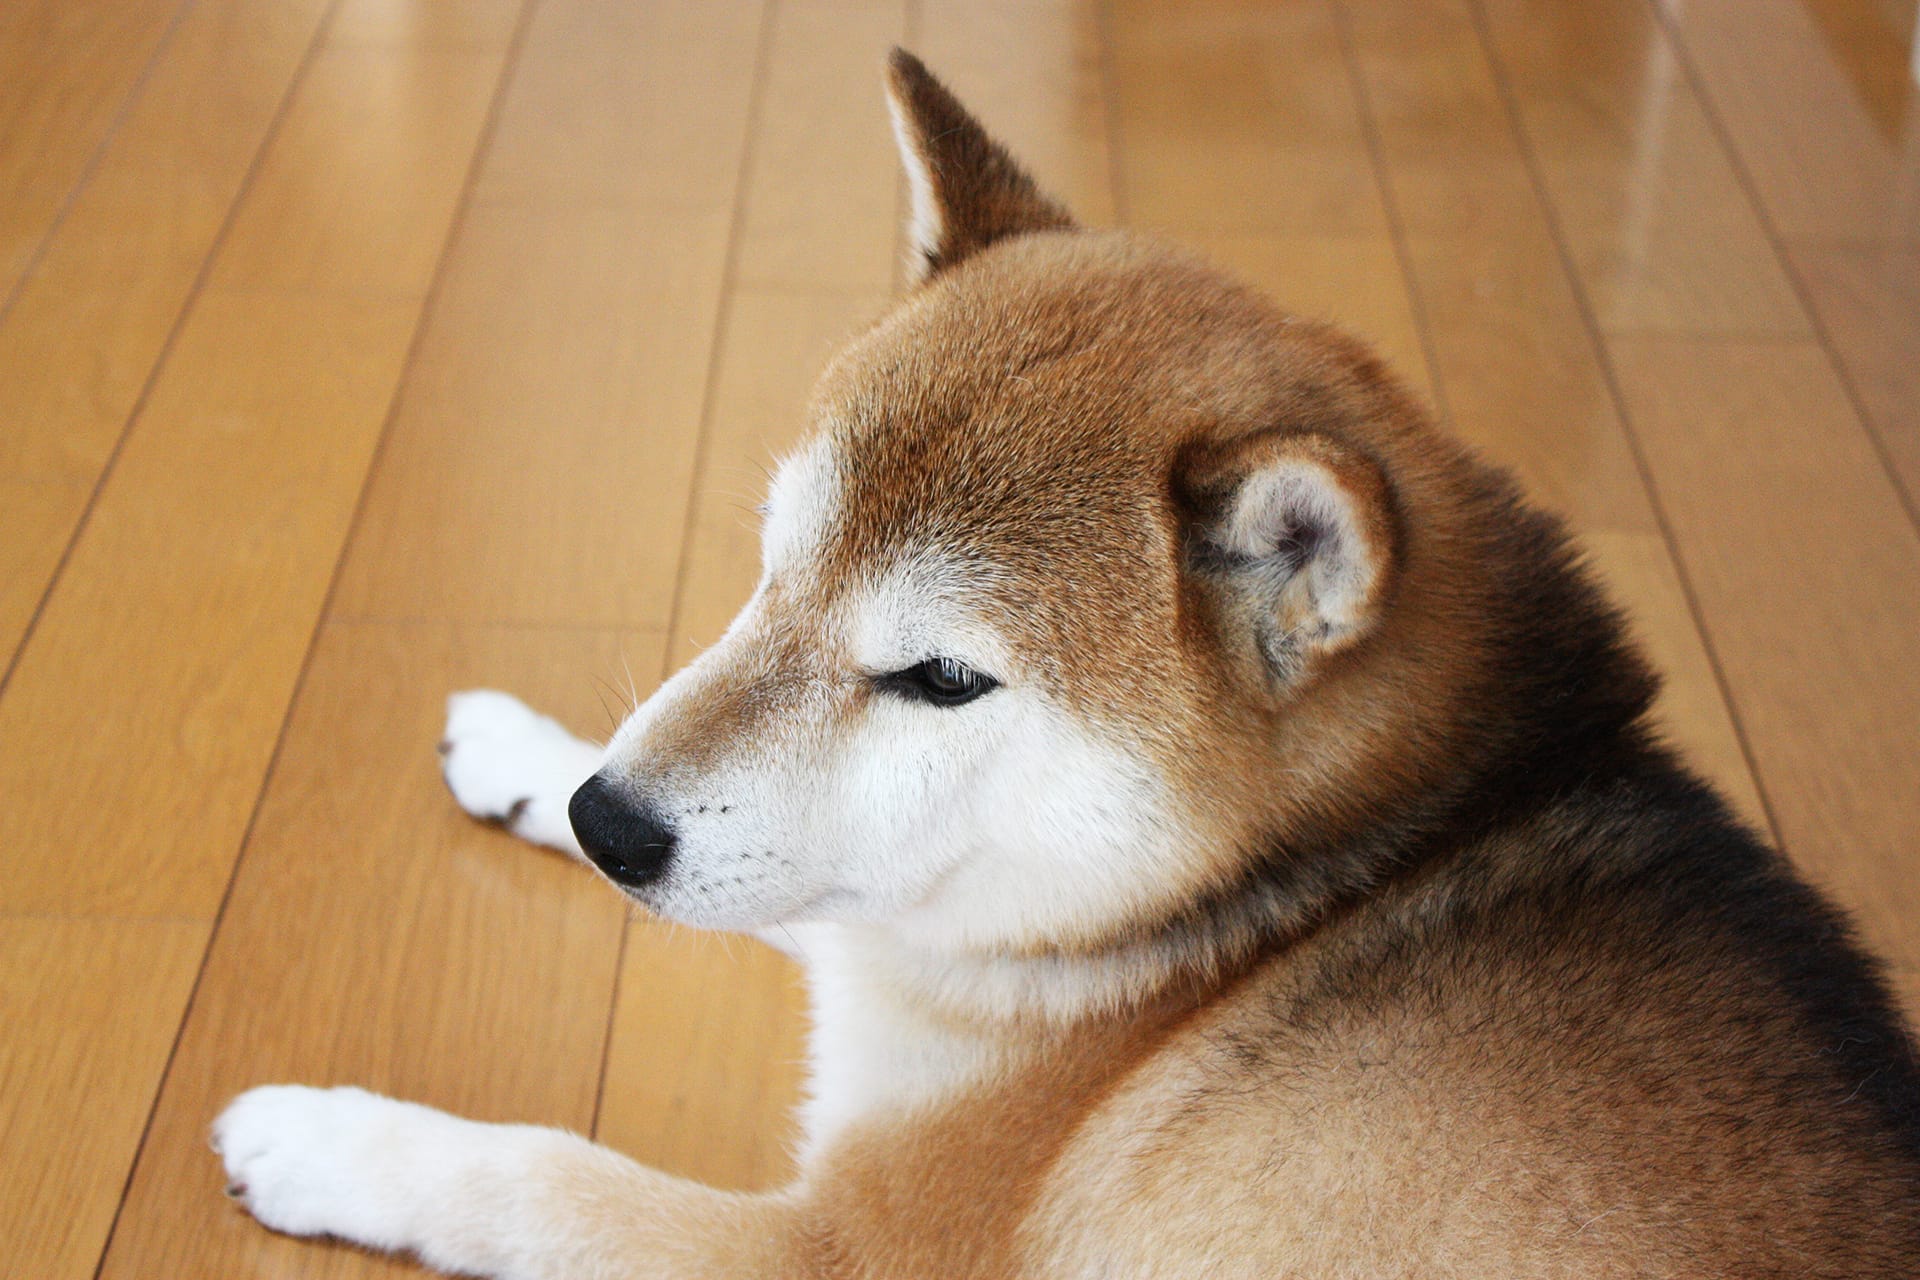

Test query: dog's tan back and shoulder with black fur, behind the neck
[1037,750,1920,1276]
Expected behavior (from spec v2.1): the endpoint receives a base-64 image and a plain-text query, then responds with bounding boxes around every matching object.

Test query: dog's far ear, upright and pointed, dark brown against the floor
[887,48,1073,282]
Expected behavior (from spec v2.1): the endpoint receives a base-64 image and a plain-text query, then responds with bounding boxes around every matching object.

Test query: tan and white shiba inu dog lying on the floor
[213,54,1920,1280]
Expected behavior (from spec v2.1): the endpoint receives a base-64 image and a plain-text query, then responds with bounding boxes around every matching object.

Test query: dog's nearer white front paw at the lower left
[213,1084,424,1249]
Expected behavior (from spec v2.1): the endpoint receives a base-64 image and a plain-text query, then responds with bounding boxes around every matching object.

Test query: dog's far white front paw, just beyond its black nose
[440,689,601,856]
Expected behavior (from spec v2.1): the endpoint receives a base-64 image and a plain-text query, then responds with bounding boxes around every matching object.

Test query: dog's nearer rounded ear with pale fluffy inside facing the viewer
[1179,432,1396,683]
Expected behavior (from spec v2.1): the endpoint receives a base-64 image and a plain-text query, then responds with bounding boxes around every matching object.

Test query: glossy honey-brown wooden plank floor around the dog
[0,0,1920,1280]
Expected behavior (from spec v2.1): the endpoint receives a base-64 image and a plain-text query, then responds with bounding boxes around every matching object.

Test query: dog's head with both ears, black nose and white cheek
[574,58,1443,948]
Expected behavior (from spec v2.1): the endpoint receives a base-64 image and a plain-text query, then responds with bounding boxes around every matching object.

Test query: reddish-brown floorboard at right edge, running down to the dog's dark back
[1615,338,1920,1000]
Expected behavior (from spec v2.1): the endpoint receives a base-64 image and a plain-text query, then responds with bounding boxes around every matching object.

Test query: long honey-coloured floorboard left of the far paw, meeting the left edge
[0,294,417,919]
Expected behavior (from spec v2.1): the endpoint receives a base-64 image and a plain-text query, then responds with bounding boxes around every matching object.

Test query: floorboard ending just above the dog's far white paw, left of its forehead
[336,205,730,628]
